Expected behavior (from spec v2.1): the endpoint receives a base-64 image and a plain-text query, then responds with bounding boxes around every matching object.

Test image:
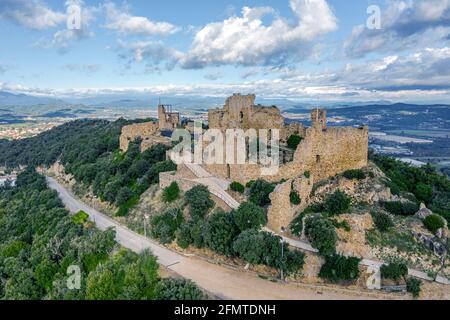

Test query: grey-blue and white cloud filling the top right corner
[344,0,450,58]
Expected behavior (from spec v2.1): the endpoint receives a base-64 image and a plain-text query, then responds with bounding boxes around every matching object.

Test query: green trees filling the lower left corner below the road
[0,170,205,300]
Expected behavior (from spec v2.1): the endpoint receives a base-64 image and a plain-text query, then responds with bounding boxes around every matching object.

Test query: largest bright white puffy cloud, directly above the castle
[182,0,337,69]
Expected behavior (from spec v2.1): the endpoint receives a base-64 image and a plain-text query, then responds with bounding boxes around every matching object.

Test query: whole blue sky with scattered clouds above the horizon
[0,0,450,103]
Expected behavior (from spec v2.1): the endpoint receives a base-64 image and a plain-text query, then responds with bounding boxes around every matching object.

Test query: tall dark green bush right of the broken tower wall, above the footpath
[305,216,337,256]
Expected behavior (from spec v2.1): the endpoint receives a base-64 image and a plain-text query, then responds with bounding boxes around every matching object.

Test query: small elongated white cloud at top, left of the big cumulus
[105,2,179,35]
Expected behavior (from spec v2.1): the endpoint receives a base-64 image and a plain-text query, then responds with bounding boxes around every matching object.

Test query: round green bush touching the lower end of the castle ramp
[233,202,267,231]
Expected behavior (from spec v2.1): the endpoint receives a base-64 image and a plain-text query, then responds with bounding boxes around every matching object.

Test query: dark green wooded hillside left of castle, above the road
[0,119,176,216]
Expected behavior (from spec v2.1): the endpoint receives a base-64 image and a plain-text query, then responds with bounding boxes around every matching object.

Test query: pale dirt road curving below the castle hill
[47,177,404,300]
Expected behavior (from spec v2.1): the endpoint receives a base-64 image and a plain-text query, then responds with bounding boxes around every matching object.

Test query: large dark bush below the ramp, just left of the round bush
[203,210,239,257]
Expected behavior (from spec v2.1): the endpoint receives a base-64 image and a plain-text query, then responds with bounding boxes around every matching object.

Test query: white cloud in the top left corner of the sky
[0,0,66,30]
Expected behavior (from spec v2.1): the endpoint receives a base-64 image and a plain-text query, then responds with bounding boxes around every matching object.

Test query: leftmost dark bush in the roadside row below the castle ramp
[151,209,184,243]
